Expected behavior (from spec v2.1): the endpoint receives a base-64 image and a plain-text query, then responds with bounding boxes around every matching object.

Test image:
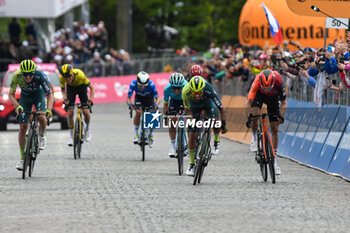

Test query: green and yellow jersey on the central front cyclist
[182,81,223,109]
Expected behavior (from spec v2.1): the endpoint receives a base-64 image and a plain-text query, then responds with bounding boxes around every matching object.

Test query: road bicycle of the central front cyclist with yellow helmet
[193,115,213,185]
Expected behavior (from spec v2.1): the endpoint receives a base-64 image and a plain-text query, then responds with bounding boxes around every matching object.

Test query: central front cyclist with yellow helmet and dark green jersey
[182,76,227,176]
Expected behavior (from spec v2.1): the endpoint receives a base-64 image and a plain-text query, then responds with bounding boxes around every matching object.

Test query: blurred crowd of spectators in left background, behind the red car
[0,18,133,77]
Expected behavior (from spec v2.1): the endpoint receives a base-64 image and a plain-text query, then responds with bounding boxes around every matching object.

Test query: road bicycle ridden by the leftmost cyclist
[22,112,50,179]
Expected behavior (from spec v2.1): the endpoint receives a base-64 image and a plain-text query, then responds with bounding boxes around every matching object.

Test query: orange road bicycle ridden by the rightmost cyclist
[251,113,276,184]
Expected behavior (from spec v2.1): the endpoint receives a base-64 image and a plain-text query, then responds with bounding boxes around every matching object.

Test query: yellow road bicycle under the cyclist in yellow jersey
[73,104,92,159]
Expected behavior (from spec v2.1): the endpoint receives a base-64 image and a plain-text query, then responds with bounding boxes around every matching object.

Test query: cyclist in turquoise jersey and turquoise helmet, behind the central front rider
[163,73,188,158]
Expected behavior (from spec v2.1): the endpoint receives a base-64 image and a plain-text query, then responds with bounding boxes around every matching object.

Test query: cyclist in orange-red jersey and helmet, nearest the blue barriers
[246,69,287,175]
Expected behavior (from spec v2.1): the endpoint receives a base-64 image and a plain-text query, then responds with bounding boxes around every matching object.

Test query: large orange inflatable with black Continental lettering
[239,0,349,50]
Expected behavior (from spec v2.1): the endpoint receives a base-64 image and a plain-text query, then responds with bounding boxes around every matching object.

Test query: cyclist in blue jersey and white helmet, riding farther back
[126,71,159,147]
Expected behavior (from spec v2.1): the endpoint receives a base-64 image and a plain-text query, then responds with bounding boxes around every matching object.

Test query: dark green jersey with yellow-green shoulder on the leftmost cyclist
[10,70,51,95]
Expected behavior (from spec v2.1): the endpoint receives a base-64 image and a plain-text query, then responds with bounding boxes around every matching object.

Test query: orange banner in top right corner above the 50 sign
[286,0,350,18]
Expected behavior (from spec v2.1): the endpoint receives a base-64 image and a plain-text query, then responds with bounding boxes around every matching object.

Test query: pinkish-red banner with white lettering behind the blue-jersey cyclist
[89,73,171,103]
